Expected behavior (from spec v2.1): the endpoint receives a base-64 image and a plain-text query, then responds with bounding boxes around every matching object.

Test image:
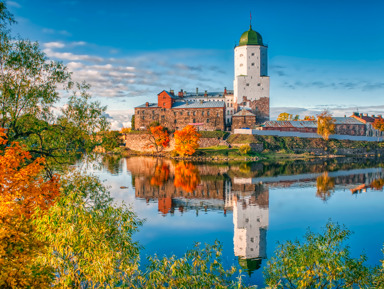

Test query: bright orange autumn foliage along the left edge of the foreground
[0,129,59,288]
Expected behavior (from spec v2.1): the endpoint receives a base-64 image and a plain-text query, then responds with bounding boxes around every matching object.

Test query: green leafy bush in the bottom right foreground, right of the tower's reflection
[264,222,372,288]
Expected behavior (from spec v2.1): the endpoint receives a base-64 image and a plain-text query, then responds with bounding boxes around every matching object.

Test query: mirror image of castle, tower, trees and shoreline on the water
[121,157,384,275]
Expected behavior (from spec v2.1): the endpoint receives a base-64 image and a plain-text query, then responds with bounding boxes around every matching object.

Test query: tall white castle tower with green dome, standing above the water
[233,25,269,121]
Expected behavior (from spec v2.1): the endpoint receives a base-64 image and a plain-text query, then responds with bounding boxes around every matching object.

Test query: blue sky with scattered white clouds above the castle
[6,0,384,129]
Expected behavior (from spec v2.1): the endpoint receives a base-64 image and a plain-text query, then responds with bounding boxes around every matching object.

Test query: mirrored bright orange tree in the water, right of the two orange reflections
[173,162,200,193]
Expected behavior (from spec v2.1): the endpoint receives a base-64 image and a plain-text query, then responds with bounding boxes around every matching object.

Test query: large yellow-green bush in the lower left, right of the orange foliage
[35,172,142,288]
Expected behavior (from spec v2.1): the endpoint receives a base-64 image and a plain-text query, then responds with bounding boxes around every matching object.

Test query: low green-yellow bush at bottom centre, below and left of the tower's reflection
[137,242,250,288]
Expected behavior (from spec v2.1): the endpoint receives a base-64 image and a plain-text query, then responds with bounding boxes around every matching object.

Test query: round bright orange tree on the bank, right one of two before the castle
[175,125,200,156]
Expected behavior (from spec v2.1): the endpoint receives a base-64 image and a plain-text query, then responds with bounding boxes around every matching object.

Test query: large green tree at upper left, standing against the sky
[0,1,108,171]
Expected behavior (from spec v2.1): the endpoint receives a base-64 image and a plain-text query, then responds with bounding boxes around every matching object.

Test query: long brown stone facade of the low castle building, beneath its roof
[135,107,225,131]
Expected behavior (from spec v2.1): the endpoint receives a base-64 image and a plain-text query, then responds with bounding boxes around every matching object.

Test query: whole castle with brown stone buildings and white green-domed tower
[134,25,269,131]
